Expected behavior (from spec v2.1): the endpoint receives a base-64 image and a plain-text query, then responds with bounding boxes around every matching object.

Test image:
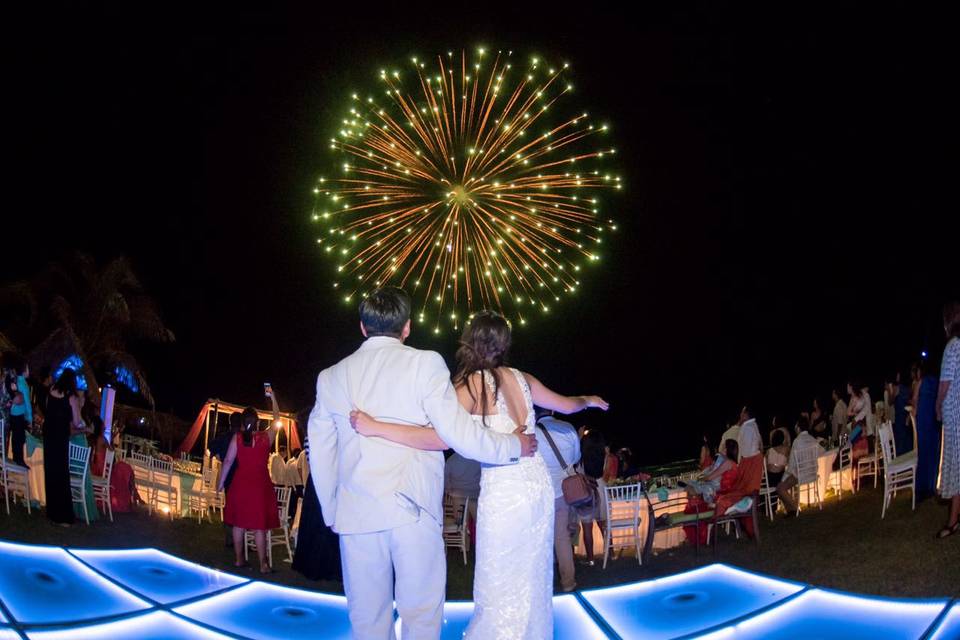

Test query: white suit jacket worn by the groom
[308,336,520,534]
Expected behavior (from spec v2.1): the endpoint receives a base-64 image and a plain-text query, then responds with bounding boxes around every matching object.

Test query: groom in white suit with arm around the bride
[308,287,537,640]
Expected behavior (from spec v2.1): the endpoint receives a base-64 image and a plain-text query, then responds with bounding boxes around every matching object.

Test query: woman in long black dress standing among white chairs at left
[43,369,81,526]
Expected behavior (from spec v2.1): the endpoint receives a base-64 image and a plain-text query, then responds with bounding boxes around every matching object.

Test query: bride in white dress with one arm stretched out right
[351,311,608,640]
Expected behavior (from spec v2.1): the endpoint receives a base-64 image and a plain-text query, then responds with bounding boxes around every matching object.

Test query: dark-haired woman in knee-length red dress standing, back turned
[219,407,280,573]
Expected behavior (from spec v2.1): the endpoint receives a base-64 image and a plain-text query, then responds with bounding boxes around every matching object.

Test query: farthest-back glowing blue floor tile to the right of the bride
[583,564,804,640]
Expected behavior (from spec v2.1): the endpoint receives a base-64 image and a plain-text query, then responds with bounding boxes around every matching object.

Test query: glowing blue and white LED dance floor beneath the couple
[0,541,960,640]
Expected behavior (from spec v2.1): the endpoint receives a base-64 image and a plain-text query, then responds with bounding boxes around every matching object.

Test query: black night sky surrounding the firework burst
[3,3,960,462]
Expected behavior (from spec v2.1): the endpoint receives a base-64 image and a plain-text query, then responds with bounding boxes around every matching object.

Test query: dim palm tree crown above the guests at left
[0,253,175,407]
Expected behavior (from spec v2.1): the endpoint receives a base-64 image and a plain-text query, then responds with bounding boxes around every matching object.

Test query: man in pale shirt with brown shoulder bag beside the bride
[537,407,580,592]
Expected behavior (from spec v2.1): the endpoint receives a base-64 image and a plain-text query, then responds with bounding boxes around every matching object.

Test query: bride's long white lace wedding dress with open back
[464,369,554,640]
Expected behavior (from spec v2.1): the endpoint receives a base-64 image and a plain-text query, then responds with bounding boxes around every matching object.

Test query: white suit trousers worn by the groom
[340,512,447,640]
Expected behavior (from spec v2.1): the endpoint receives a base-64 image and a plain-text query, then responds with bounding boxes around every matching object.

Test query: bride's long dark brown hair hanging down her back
[453,311,510,426]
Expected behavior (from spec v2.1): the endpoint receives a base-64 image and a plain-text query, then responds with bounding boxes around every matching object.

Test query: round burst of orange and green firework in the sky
[313,49,621,333]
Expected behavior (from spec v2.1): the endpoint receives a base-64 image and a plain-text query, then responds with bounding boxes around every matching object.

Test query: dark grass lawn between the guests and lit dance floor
[0,488,960,600]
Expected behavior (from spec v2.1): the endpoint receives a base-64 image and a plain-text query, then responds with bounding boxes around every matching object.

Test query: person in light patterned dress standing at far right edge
[937,302,960,538]
